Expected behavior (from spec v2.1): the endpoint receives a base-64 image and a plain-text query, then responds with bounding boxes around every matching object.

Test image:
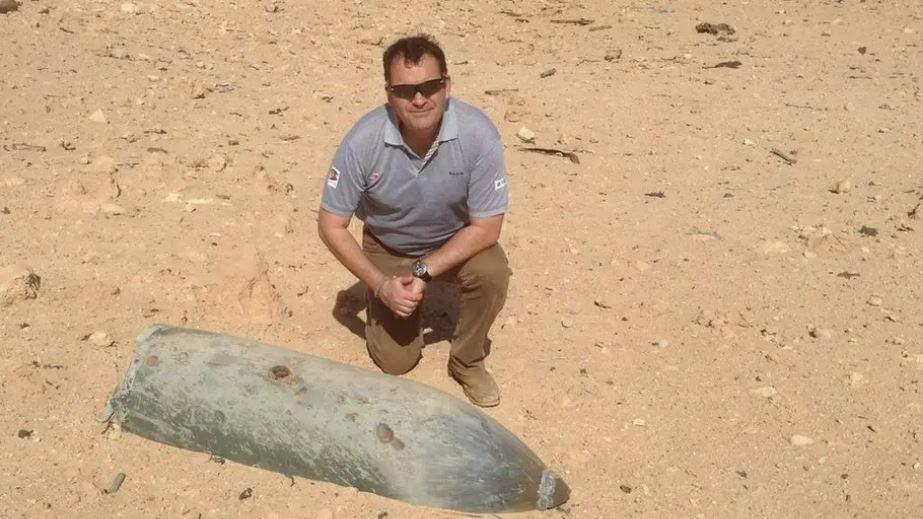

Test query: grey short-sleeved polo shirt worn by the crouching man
[321,99,507,256]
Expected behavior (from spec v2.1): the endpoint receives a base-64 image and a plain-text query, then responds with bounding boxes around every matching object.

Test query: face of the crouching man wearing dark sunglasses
[388,54,451,137]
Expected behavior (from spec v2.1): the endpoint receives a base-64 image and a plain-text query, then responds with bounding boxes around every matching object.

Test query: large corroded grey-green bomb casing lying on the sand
[110,326,570,513]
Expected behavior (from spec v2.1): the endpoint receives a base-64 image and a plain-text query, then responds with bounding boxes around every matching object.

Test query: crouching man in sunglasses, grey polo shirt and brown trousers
[318,35,510,407]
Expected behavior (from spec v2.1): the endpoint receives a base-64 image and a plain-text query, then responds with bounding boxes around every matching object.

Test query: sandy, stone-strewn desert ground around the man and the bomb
[0,0,923,519]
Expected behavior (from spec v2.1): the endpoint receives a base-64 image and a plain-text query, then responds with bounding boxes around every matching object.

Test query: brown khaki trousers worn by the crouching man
[362,232,510,375]
